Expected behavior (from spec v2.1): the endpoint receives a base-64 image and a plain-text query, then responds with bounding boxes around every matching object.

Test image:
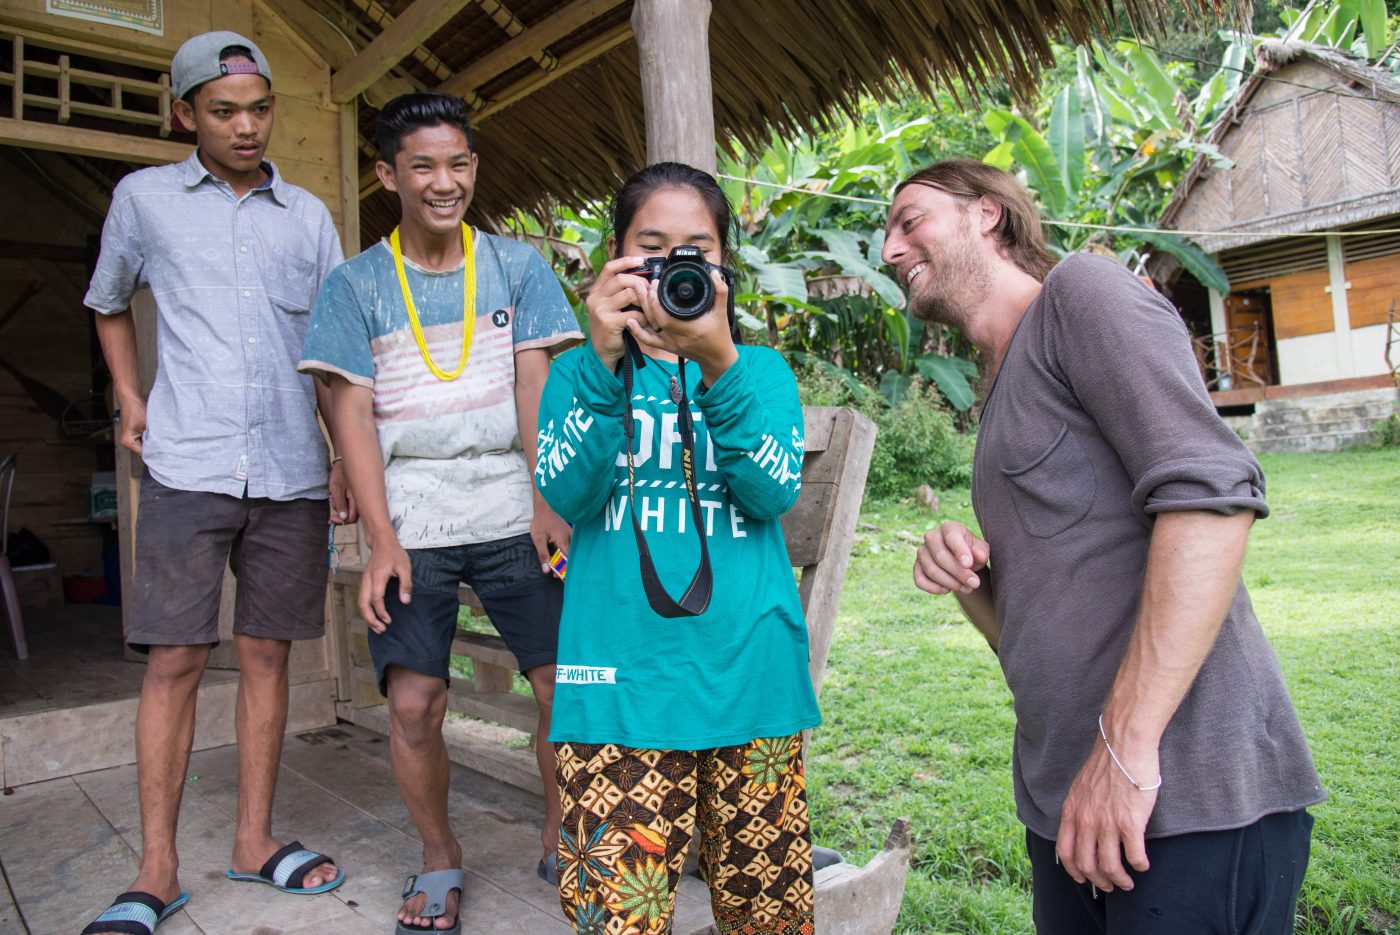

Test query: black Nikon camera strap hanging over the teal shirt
[622,332,714,617]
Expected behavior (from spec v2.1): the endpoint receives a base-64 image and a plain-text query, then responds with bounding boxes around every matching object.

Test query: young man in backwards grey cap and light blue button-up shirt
[84,32,356,935]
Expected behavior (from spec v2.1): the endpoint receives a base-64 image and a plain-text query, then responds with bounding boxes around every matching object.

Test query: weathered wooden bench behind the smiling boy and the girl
[326,407,875,794]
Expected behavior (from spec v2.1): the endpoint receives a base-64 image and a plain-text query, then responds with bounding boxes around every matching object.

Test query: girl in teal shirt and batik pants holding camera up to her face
[535,162,820,935]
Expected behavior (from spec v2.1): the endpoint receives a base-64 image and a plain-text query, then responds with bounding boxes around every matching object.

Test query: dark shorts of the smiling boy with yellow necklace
[370,535,564,694]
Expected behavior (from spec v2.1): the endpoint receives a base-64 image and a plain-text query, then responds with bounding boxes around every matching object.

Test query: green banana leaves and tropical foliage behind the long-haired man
[515,0,1400,426]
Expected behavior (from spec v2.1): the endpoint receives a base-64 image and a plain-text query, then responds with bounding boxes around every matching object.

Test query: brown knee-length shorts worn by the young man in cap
[126,473,329,652]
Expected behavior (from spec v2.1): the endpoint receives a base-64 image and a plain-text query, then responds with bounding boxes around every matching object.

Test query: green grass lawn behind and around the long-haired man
[809,448,1400,935]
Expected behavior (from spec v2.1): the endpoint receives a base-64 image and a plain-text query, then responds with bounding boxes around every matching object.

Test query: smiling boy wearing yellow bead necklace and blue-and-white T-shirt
[301,94,582,932]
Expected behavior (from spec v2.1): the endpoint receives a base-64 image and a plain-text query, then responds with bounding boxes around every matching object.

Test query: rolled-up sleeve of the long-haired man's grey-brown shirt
[1044,255,1268,518]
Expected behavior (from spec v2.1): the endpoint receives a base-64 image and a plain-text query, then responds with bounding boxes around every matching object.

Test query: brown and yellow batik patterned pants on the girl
[556,733,815,935]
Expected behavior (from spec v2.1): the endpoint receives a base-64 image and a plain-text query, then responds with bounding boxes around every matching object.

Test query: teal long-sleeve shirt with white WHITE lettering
[535,346,820,750]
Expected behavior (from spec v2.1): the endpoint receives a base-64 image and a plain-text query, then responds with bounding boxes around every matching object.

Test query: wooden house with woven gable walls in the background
[1148,41,1400,448]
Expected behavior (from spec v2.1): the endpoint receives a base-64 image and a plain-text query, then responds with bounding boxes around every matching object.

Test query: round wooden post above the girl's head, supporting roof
[631,0,715,174]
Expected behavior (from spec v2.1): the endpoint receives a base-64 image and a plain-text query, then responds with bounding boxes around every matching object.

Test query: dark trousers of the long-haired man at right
[1026,809,1313,935]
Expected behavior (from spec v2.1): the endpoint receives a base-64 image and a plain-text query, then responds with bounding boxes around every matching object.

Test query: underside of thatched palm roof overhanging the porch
[322,0,1233,241]
